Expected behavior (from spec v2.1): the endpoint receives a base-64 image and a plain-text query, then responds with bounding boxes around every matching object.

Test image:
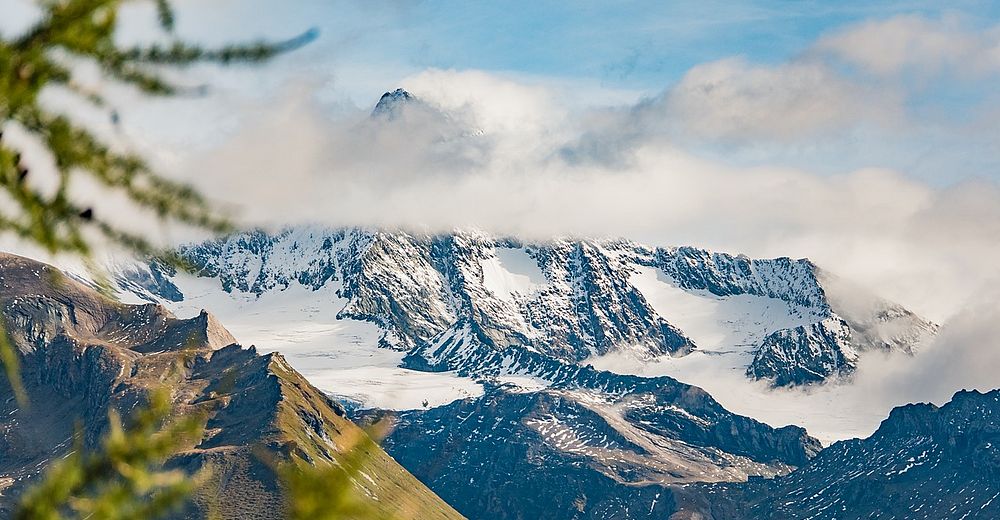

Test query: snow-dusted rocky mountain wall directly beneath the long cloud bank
[119,228,936,386]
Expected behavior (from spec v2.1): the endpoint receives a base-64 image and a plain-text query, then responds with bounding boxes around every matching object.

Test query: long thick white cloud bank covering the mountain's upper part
[164,73,1000,320]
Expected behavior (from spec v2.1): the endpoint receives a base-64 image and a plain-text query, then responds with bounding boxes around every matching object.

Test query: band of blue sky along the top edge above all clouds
[146,0,1000,92]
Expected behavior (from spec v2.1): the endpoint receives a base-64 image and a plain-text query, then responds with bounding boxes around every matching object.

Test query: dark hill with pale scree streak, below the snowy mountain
[369,371,819,519]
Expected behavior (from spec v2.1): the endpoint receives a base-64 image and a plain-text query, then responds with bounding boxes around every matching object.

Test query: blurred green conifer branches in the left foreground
[0,4,406,520]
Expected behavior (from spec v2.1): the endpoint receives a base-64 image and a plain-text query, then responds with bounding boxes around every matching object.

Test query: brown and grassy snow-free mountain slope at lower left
[0,254,459,519]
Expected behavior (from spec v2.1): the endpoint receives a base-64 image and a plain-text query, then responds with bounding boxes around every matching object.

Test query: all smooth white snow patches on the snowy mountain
[115,254,905,444]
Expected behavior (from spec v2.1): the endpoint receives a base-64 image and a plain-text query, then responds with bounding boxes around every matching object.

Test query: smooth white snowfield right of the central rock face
[586,267,888,444]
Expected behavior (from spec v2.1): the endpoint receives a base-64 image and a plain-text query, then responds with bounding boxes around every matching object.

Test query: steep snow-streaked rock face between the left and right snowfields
[143,229,690,361]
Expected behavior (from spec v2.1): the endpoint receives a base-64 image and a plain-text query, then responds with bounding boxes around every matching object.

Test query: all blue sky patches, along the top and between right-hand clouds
[107,0,1000,185]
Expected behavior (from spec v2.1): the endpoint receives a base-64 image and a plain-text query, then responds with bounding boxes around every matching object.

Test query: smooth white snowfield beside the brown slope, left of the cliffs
[117,275,483,410]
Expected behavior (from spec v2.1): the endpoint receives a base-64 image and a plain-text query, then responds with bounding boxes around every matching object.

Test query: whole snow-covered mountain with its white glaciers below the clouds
[111,227,936,443]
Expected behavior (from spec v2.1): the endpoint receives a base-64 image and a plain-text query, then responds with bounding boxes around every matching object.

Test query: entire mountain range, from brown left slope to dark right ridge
[0,217,1000,519]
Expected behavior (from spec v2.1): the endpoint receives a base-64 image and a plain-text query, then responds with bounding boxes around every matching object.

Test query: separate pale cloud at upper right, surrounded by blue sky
[612,15,1000,146]
